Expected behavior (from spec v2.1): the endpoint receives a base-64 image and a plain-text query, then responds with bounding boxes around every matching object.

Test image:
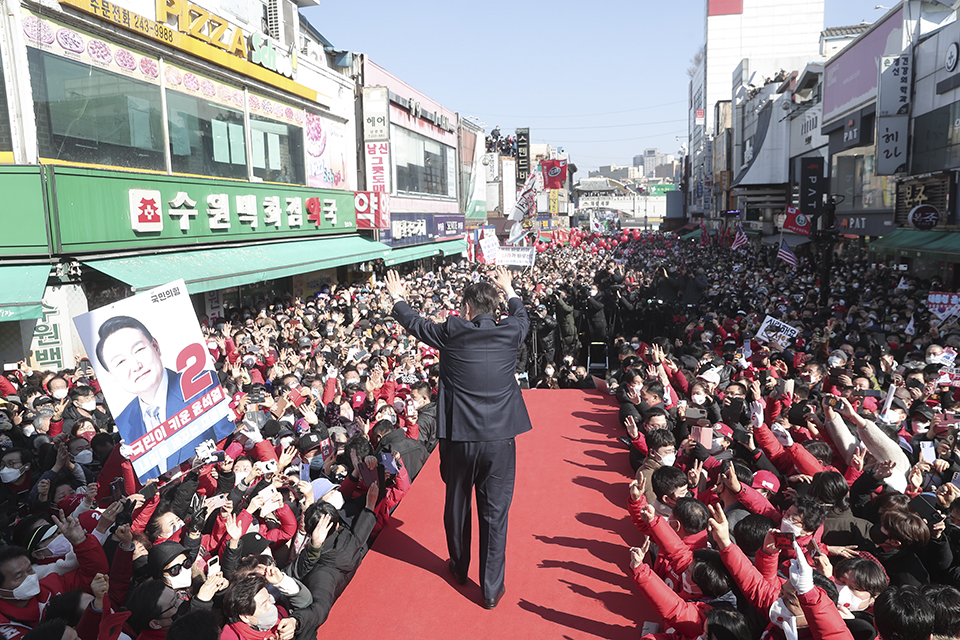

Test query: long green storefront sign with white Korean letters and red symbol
[49,167,357,253]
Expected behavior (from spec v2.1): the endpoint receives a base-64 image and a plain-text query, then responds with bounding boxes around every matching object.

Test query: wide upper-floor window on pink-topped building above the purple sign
[390,126,457,198]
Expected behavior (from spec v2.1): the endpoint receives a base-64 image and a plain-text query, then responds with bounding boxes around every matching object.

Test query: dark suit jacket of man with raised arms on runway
[393,297,532,442]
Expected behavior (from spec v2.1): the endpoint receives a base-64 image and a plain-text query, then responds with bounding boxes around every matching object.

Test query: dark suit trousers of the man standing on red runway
[440,438,517,598]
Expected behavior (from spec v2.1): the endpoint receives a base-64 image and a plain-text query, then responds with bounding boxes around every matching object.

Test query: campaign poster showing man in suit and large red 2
[74,280,234,482]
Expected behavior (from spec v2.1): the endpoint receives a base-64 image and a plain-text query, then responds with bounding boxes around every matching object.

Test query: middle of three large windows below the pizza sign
[167,91,247,179]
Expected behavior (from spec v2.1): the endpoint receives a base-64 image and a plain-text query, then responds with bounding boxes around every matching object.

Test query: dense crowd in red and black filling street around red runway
[0,226,960,640]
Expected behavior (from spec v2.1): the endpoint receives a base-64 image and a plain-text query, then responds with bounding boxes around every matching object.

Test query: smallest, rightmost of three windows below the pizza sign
[250,114,304,184]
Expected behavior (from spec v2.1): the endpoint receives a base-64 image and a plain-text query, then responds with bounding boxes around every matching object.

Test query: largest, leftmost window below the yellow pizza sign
[27,47,164,171]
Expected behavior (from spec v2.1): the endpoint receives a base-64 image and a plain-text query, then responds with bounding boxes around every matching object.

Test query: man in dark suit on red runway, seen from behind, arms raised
[386,267,532,609]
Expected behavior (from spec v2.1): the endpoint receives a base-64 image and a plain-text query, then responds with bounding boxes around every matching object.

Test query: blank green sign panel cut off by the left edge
[0,166,48,256]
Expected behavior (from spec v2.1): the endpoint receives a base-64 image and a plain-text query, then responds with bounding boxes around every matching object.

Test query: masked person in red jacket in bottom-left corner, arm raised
[0,517,110,626]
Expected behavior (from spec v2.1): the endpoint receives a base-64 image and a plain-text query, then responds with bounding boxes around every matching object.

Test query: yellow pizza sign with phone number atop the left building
[60,0,330,106]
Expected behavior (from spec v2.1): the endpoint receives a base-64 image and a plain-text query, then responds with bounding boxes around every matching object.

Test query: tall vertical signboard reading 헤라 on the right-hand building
[877,52,912,176]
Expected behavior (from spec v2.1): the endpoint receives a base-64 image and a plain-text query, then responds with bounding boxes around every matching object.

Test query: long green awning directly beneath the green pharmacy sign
[84,236,390,293]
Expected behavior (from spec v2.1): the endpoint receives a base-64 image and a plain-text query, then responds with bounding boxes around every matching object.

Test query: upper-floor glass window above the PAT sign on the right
[830,147,896,213]
